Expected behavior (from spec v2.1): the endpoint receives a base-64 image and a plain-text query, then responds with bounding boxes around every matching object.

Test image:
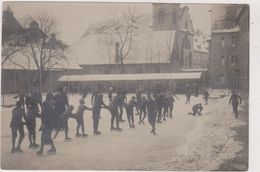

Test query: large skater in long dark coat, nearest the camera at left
[37,100,57,155]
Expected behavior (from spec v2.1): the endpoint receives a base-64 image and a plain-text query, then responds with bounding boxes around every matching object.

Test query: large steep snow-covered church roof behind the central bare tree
[71,15,175,64]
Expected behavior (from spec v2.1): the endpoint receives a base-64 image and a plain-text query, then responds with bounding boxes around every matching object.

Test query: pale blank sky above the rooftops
[3,2,210,45]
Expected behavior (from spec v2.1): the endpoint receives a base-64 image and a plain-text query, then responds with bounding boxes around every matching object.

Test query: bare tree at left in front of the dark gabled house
[19,13,70,89]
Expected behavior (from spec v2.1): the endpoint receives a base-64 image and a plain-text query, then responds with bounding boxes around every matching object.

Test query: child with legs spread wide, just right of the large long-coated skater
[53,105,76,142]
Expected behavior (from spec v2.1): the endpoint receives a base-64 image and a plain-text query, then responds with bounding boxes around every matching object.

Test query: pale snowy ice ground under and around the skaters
[1,95,248,170]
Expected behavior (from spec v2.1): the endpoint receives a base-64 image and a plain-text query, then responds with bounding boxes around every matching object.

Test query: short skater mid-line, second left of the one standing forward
[125,96,138,128]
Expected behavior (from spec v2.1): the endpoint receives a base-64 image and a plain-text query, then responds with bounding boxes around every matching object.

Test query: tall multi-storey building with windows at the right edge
[209,5,249,89]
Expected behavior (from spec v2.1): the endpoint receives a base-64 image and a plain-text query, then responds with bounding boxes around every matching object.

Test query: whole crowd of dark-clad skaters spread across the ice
[5,84,241,155]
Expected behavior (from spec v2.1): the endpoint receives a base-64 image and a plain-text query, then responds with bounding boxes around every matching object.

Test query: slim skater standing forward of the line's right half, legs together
[146,94,157,135]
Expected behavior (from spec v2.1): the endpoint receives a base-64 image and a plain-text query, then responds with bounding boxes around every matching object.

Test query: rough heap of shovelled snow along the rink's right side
[166,99,246,170]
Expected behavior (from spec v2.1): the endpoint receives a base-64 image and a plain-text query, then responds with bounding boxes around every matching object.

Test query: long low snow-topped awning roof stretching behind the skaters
[58,72,201,82]
